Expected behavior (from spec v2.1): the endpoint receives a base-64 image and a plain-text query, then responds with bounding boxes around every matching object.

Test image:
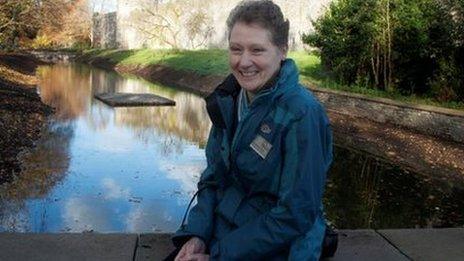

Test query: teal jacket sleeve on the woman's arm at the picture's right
[211,106,332,260]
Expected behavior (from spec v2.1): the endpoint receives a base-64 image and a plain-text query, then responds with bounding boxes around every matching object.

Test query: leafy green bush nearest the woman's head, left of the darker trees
[303,0,378,84]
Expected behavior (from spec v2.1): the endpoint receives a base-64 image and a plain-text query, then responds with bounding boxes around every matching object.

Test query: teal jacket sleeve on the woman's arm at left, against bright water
[172,126,218,247]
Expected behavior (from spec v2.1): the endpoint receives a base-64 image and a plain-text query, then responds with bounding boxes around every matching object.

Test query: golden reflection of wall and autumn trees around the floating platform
[39,65,211,144]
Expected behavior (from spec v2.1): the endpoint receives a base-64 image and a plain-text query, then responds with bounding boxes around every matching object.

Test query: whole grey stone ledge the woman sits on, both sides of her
[0,228,464,261]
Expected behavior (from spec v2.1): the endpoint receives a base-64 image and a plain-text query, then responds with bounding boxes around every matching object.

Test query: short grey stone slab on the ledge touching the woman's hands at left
[135,234,174,261]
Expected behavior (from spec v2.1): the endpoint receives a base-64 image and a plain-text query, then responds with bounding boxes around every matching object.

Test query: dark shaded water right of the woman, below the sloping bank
[324,147,464,229]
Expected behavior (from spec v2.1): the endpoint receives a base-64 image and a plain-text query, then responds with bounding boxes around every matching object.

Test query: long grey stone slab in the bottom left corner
[0,233,137,261]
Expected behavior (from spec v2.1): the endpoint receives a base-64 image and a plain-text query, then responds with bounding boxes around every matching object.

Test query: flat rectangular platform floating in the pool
[95,93,176,107]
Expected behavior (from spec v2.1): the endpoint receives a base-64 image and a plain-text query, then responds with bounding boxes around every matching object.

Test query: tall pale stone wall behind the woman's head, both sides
[109,0,332,49]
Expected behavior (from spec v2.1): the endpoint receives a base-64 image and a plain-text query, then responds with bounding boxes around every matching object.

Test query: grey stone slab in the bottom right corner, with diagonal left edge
[378,228,464,261]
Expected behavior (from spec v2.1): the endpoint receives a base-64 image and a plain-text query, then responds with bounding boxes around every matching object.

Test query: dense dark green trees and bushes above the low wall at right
[303,0,464,101]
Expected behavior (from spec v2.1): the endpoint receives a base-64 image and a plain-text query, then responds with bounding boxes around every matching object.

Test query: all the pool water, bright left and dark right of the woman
[0,64,464,232]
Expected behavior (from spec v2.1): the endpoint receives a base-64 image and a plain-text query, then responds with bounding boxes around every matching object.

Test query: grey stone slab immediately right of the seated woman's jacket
[326,230,408,261]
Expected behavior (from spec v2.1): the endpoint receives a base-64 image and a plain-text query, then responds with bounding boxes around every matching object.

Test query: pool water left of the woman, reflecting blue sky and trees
[0,65,210,232]
